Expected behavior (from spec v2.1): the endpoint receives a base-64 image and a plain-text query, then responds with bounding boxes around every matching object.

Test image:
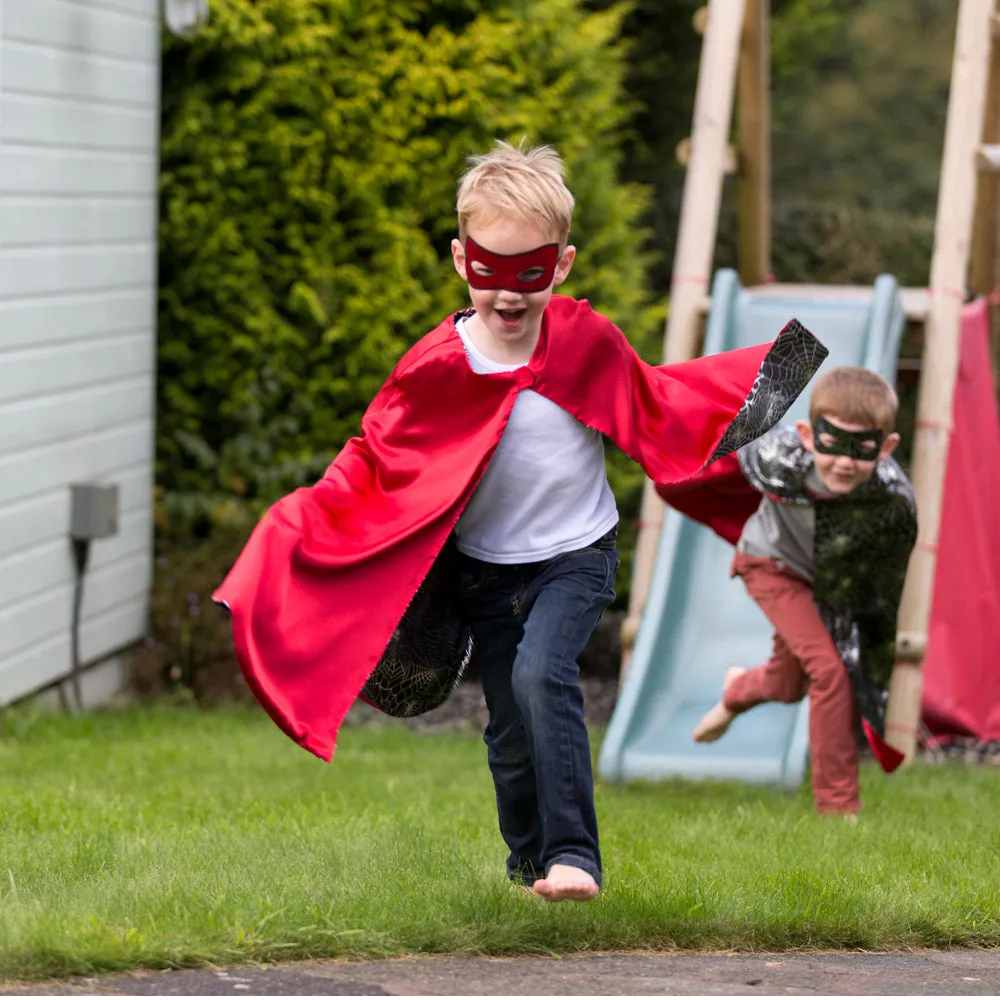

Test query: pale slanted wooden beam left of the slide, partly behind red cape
[620,0,745,679]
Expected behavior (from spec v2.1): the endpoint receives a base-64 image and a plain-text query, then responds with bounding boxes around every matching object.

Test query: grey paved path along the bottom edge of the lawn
[0,950,1000,996]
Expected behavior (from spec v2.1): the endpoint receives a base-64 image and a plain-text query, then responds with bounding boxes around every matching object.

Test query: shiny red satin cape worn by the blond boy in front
[214,296,826,760]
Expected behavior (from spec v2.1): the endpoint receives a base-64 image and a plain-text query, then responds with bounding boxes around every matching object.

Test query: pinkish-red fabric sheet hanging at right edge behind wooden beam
[918,301,1000,740]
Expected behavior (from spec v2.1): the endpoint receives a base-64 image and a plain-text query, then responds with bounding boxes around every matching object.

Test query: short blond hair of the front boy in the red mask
[457,139,574,243]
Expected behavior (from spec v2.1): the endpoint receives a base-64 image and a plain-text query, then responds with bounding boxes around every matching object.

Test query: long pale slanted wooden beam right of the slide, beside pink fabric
[886,0,994,761]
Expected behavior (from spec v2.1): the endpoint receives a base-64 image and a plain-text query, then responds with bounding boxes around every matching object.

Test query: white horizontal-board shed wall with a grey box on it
[0,0,160,703]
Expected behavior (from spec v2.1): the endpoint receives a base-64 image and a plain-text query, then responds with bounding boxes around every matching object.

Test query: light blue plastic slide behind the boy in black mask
[598,270,905,788]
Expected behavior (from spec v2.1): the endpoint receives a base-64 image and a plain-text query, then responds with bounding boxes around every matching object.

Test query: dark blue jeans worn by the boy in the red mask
[460,528,618,885]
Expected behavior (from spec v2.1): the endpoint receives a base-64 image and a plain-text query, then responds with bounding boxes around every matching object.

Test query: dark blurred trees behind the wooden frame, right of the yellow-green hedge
[590,0,957,290]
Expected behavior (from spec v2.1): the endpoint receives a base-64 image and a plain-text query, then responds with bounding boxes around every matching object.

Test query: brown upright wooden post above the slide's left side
[736,0,771,285]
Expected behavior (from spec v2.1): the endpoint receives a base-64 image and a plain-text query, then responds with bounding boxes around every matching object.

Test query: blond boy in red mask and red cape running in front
[216,142,826,901]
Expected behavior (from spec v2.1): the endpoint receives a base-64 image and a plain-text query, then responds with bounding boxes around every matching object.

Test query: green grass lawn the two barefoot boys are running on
[0,706,1000,977]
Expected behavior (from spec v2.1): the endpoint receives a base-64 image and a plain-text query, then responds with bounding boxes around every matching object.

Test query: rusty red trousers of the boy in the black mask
[723,552,861,813]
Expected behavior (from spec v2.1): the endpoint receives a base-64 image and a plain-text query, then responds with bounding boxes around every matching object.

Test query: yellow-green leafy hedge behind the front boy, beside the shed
[157,0,661,502]
